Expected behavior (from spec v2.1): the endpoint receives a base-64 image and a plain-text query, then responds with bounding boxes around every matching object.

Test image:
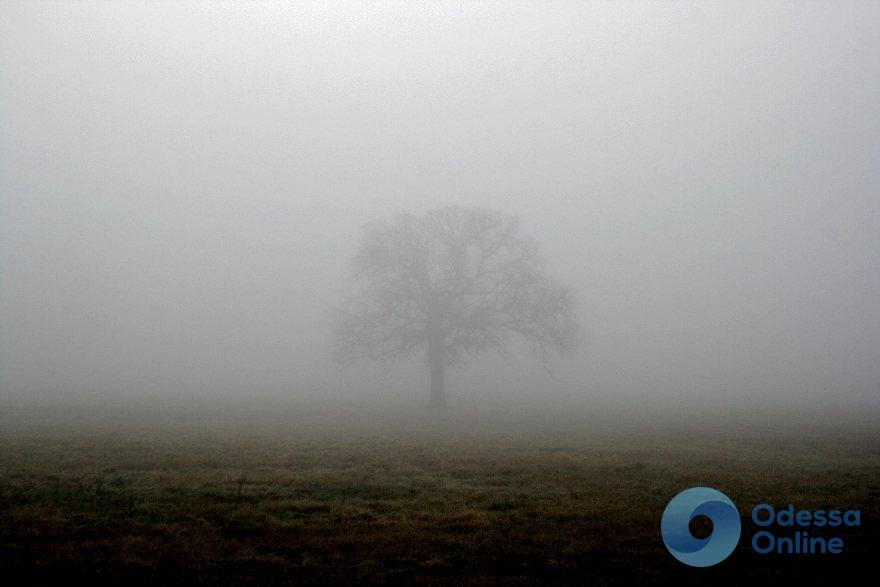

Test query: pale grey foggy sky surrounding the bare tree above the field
[0,2,880,413]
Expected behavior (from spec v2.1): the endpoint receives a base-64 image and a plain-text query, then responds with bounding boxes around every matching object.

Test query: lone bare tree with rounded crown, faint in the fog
[336,207,578,407]
